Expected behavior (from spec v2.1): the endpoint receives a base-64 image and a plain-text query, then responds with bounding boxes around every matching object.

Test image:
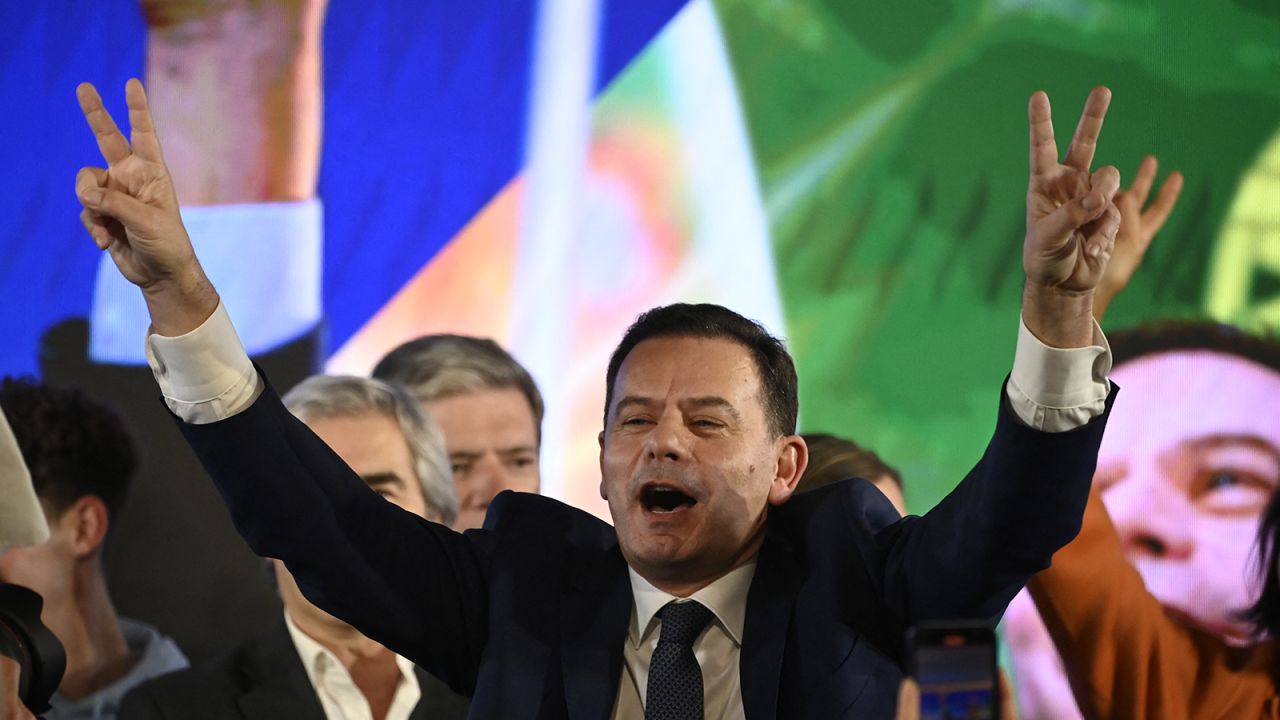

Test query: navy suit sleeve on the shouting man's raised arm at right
[877,386,1116,623]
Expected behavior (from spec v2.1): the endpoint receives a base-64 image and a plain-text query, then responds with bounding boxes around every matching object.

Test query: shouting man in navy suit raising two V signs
[77,81,1119,719]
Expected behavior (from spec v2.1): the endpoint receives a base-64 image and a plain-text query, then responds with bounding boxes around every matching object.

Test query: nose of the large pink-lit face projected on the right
[1103,480,1196,560]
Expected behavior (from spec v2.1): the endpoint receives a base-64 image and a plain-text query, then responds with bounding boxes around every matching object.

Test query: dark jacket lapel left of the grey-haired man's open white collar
[238,623,324,720]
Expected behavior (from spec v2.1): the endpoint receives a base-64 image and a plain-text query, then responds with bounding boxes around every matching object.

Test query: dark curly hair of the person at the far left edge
[0,377,138,521]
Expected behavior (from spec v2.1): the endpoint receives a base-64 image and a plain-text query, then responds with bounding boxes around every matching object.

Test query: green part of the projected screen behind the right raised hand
[716,0,1280,509]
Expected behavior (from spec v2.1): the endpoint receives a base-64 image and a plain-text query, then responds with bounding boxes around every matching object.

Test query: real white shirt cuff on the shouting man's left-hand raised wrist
[146,304,262,425]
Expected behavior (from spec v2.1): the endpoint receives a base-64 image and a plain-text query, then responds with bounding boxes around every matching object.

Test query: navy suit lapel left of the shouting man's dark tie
[561,547,631,720]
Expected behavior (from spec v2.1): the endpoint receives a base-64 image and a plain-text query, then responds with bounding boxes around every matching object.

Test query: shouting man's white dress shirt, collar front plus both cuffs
[147,299,1111,719]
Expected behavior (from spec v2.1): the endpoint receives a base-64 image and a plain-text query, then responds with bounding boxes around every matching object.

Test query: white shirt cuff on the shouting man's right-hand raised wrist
[1006,312,1111,432]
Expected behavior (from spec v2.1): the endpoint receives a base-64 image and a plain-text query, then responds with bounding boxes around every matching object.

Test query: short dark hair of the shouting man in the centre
[604,302,800,436]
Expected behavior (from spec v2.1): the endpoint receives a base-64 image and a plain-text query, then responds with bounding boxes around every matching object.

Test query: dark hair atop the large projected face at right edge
[1107,320,1280,373]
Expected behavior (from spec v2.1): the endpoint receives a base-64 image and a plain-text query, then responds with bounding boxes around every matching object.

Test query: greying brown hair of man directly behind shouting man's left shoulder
[372,333,545,439]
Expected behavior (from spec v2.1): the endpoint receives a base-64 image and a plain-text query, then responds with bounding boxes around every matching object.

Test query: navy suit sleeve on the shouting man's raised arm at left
[171,386,493,694]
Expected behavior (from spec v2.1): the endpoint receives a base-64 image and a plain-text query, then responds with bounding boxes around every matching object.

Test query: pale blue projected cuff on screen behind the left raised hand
[88,200,324,365]
